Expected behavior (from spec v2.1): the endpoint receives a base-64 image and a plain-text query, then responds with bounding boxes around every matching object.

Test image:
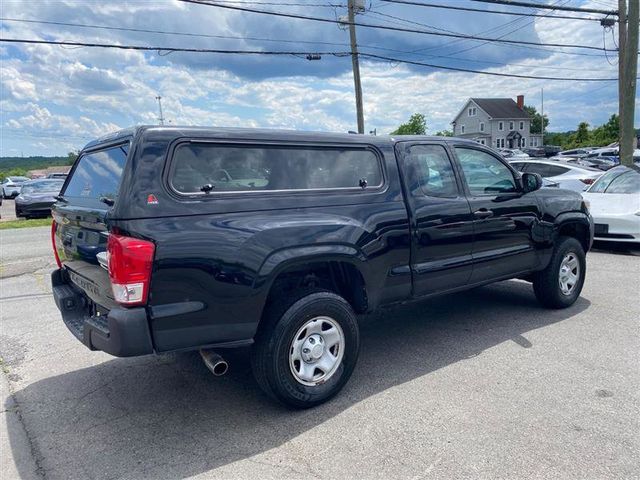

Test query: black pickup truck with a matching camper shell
[51,127,593,408]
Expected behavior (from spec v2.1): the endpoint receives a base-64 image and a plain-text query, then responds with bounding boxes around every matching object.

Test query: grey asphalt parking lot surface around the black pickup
[0,227,640,479]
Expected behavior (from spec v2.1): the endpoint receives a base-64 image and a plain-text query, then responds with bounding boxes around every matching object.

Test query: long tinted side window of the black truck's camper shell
[168,142,384,195]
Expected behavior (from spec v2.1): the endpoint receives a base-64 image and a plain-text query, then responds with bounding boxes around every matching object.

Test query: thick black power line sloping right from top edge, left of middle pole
[179,0,616,51]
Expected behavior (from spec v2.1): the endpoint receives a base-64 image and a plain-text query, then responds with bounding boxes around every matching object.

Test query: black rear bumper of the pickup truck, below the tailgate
[51,269,153,357]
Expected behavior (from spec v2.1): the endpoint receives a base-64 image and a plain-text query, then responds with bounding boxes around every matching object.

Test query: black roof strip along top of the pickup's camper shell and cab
[83,125,476,150]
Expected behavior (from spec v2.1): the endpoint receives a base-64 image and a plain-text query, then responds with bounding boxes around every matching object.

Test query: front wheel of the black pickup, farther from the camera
[533,237,587,308]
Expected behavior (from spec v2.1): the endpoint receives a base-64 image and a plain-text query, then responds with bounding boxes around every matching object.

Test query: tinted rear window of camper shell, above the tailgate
[64,145,129,200]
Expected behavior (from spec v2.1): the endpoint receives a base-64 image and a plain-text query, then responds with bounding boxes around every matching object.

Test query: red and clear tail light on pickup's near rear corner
[107,233,155,306]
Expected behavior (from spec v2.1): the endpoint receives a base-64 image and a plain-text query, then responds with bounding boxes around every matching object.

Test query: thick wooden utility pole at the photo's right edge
[618,0,640,166]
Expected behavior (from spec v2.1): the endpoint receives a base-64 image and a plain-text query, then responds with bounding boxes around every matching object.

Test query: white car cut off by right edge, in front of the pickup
[582,166,640,242]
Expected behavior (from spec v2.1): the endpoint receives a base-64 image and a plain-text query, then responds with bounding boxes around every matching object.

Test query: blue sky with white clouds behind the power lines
[0,0,640,156]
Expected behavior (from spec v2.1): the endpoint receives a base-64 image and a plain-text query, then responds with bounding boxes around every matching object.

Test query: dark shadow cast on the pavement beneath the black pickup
[12,281,590,479]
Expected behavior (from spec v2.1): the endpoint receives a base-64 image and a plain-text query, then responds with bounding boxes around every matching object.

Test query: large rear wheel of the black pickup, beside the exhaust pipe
[251,290,360,408]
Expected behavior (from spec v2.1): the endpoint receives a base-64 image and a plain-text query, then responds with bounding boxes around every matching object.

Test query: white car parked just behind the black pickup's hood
[509,159,603,192]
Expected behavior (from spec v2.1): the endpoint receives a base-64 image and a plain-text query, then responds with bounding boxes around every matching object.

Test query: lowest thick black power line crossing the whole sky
[0,38,617,82]
